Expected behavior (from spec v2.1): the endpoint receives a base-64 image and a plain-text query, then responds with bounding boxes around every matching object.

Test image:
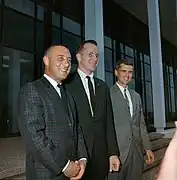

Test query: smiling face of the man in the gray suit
[115,64,133,87]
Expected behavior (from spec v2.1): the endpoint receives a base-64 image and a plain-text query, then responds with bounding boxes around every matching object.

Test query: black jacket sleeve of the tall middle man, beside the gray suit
[106,86,120,156]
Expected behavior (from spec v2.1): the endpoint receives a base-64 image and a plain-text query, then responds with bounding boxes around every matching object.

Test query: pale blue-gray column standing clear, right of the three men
[147,0,166,133]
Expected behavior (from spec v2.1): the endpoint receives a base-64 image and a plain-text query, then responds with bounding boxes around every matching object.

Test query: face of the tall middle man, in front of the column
[77,43,99,74]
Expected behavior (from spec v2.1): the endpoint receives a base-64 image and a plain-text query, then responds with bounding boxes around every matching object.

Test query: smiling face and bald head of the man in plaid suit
[44,46,71,82]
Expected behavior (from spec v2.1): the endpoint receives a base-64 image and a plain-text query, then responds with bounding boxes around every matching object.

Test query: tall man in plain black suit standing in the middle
[66,40,120,180]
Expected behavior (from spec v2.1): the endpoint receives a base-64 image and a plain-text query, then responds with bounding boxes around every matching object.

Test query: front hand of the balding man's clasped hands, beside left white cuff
[63,161,81,178]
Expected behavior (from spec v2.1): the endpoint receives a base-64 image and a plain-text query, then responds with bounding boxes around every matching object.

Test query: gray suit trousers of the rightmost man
[108,143,144,180]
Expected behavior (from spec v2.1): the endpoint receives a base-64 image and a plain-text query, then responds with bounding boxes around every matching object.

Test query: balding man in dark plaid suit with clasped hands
[19,45,87,180]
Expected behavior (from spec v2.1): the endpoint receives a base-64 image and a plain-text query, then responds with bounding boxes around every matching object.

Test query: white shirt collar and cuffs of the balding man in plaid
[44,74,87,172]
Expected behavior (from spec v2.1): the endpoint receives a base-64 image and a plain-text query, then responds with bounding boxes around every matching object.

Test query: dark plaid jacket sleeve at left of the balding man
[18,84,68,175]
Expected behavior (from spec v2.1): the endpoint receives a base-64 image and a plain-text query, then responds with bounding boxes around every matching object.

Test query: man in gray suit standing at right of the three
[109,60,154,180]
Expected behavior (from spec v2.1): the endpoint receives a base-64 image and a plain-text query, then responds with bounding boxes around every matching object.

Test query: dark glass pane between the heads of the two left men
[62,32,81,63]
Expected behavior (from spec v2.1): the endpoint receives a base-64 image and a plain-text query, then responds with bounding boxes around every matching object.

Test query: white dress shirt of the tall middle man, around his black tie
[77,68,95,116]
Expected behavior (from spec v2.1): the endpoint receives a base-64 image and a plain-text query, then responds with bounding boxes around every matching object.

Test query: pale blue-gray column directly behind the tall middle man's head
[84,0,105,80]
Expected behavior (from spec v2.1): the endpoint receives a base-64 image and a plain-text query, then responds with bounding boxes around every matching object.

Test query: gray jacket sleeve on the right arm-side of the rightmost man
[139,96,151,150]
